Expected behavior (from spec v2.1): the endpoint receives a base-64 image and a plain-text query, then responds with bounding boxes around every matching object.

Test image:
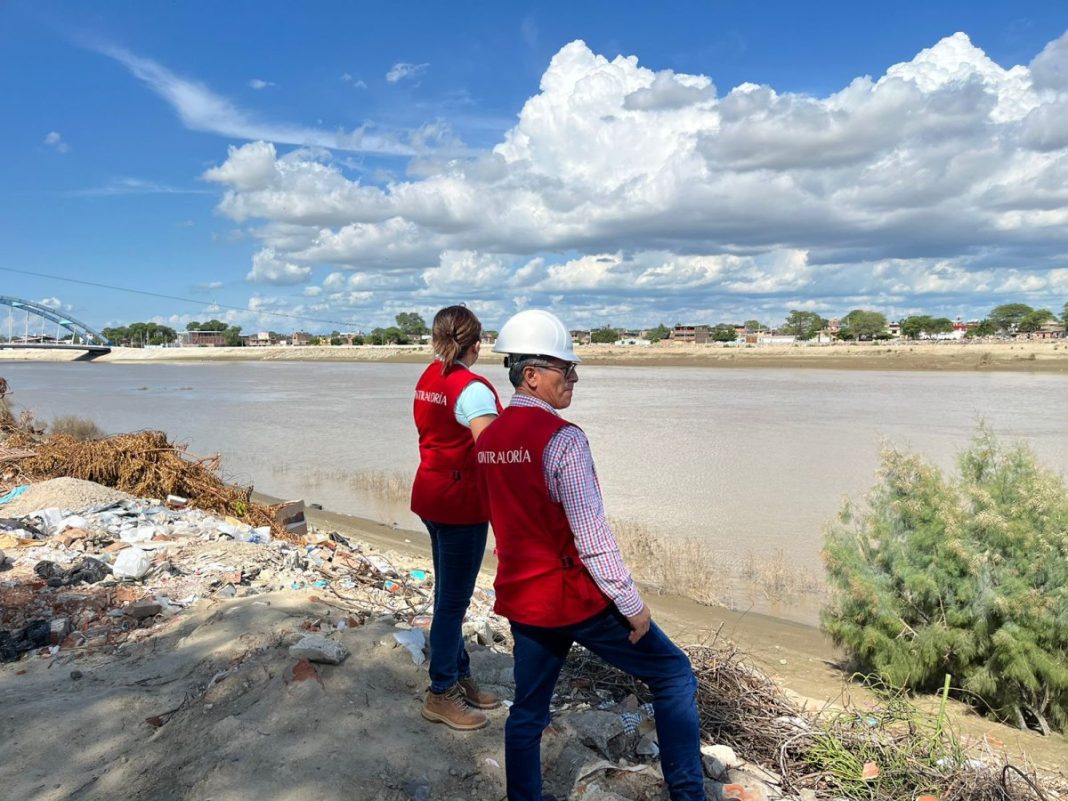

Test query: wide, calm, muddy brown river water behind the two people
[0,362,1068,616]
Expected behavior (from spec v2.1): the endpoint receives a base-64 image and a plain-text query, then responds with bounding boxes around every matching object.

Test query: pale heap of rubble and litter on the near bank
[0,499,505,663]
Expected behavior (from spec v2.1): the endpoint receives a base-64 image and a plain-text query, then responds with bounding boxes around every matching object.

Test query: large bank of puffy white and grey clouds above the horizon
[204,33,1068,325]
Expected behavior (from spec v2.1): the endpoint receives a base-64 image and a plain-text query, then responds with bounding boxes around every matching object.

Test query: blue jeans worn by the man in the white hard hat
[504,607,705,801]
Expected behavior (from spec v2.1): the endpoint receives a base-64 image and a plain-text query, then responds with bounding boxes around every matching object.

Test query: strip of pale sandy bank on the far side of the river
[6,341,1068,375]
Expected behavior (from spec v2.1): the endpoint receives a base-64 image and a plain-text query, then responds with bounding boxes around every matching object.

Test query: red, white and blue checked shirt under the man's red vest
[508,392,642,616]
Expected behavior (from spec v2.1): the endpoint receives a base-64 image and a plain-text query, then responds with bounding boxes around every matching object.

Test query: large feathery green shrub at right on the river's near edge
[821,426,1068,733]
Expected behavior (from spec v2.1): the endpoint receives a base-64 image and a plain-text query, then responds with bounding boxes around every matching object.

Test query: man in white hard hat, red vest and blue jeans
[475,310,705,801]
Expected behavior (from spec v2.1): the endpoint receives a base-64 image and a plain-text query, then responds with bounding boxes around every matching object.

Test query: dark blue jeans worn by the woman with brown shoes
[423,520,489,692]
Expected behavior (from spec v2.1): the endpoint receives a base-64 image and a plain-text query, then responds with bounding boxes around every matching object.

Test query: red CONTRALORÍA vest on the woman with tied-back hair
[411,361,502,525]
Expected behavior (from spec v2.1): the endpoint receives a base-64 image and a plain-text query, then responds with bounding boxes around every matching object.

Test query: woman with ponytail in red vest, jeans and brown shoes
[411,305,501,731]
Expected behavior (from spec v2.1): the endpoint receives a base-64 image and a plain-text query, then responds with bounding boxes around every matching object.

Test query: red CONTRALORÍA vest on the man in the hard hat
[475,406,611,627]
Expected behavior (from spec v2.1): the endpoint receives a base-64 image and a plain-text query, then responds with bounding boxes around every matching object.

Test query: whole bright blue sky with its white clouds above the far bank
[0,0,1068,331]
